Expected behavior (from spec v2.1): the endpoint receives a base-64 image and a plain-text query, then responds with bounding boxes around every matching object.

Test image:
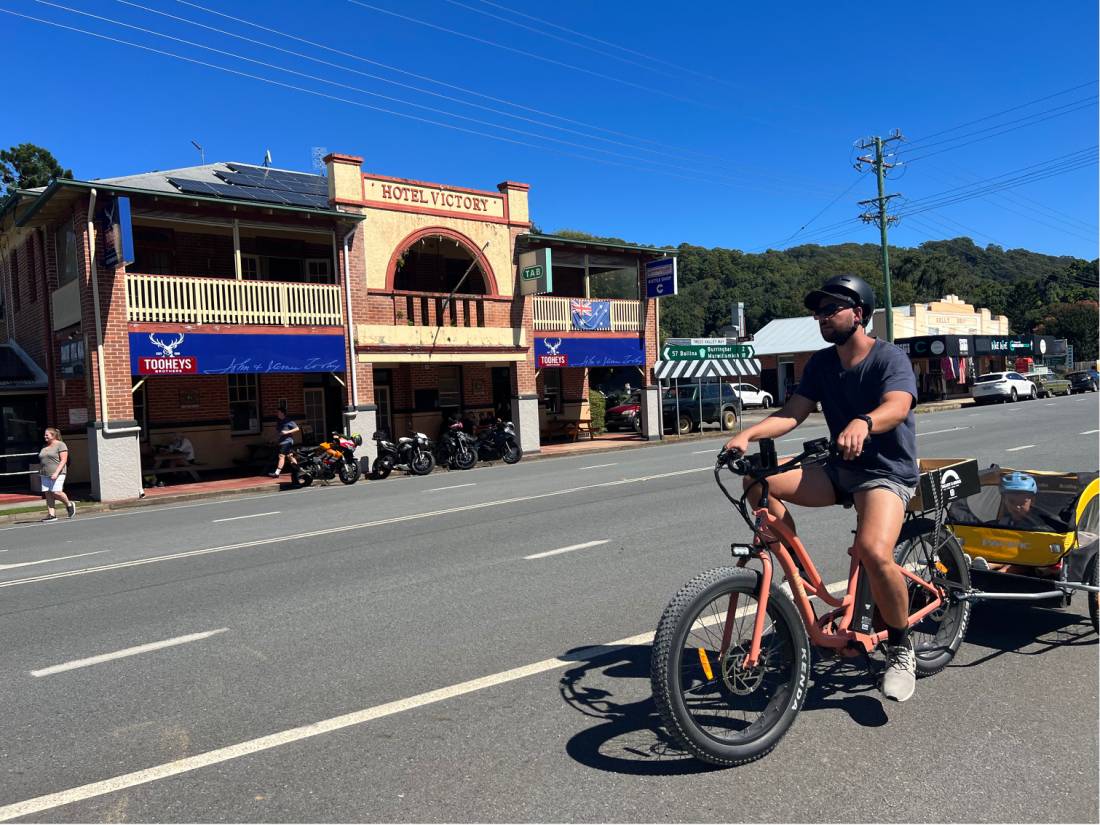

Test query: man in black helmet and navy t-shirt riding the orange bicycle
[726,275,919,702]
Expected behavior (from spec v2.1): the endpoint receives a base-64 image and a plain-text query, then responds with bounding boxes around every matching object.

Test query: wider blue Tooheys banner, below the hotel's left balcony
[130,332,347,375]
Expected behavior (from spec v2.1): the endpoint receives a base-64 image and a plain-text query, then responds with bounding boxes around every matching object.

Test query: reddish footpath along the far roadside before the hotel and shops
[0,398,974,525]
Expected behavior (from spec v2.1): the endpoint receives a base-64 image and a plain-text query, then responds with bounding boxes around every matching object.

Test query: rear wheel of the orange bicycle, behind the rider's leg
[894,530,970,678]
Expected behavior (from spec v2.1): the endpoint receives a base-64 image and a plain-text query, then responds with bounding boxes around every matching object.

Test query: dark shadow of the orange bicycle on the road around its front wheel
[559,645,888,776]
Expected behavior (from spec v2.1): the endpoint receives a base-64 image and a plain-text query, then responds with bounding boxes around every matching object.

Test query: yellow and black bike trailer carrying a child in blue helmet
[946,464,1100,630]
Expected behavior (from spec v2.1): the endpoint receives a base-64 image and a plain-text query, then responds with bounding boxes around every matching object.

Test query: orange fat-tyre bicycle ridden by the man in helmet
[650,439,970,766]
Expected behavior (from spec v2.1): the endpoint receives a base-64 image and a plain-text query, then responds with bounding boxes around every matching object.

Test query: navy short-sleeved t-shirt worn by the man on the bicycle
[798,339,917,487]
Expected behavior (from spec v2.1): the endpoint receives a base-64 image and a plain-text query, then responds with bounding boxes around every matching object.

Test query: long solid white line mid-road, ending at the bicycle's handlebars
[0,466,712,587]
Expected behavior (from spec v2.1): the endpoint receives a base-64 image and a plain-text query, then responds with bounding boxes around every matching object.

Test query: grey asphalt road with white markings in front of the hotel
[0,395,1100,822]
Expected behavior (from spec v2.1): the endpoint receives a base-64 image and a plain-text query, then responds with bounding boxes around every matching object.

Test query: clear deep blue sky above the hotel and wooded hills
[0,0,1098,259]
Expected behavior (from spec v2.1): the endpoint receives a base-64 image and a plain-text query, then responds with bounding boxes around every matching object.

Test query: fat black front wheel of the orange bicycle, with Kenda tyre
[650,567,811,766]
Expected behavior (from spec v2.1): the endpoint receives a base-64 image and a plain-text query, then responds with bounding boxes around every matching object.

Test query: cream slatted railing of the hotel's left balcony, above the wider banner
[127,278,343,327]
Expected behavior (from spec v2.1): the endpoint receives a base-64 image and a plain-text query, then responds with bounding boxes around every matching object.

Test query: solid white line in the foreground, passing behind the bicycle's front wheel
[0,580,848,822]
